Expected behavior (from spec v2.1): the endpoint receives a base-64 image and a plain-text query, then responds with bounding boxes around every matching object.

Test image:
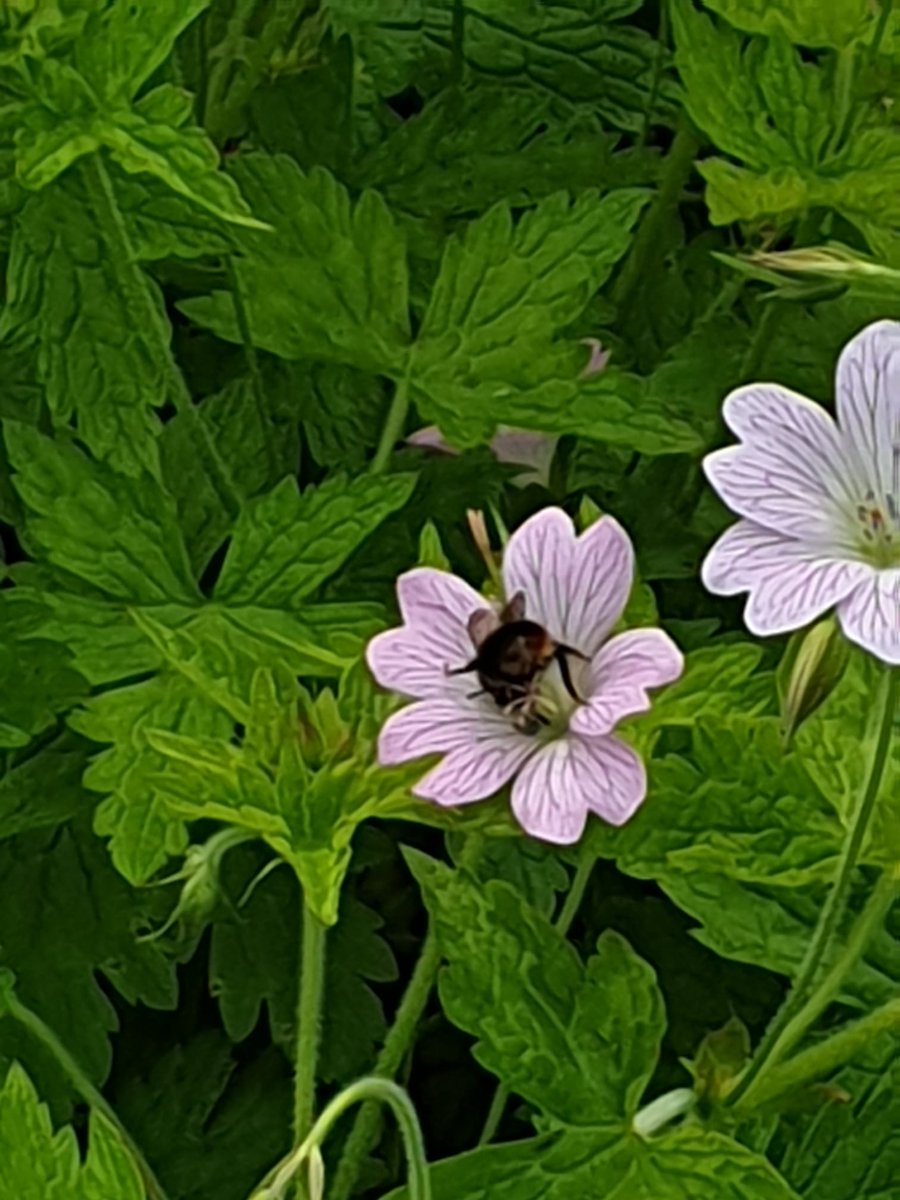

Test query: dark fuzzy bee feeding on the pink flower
[448,592,587,733]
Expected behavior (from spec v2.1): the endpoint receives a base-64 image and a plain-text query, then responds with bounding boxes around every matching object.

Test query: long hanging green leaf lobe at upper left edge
[2,173,166,475]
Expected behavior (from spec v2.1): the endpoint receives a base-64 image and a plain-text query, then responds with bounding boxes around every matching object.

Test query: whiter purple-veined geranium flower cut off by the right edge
[703,320,900,665]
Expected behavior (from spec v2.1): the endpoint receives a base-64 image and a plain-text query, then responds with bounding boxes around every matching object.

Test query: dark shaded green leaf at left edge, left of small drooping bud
[0,821,176,1087]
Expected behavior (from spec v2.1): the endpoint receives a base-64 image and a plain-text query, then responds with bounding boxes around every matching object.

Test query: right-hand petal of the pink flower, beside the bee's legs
[569,629,684,737]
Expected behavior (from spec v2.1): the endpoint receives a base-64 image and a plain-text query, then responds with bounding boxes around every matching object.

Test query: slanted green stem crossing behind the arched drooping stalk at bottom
[329,930,440,1200]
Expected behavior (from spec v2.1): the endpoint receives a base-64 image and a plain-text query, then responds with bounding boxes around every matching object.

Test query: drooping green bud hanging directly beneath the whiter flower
[775,617,850,745]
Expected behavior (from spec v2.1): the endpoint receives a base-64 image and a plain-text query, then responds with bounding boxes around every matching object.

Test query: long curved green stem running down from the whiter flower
[726,668,900,1105]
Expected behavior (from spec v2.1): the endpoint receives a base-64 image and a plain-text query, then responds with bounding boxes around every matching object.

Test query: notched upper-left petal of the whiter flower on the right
[703,384,862,544]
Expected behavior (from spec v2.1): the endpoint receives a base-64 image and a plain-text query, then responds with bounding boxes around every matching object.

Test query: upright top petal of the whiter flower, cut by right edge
[836,320,900,502]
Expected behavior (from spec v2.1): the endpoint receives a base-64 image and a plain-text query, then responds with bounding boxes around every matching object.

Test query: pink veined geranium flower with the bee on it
[367,508,683,844]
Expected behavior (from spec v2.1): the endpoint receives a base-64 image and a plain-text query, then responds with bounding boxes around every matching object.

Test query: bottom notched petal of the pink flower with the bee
[512,736,647,845]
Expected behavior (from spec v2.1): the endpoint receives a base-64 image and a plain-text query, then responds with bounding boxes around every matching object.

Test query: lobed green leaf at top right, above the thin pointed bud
[673,0,900,228]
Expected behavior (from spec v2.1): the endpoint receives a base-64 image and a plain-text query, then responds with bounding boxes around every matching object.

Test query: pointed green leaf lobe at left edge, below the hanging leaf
[4,421,199,604]
